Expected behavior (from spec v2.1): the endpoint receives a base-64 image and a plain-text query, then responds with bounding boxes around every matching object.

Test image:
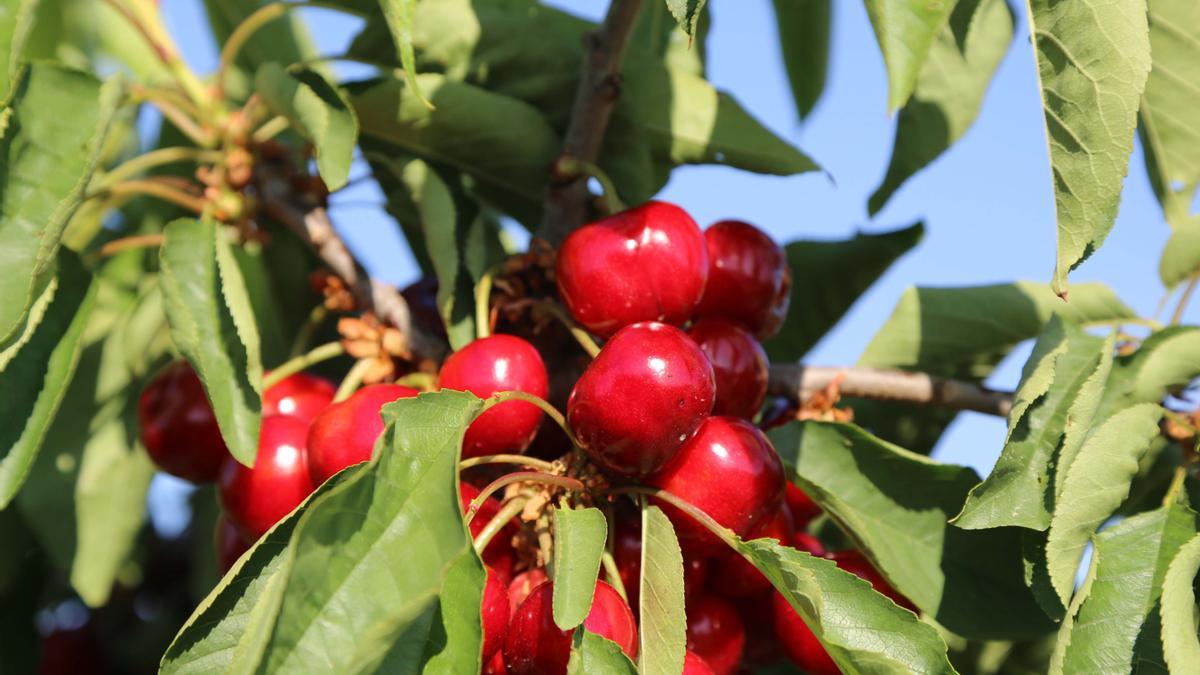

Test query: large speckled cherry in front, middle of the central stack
[566,322,716,476]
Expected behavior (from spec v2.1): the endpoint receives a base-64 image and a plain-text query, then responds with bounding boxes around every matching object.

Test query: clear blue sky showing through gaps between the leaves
[164,0,1200,474]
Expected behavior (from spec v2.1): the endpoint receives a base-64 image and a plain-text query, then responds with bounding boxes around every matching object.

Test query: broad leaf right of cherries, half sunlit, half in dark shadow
[769,423,1051,639]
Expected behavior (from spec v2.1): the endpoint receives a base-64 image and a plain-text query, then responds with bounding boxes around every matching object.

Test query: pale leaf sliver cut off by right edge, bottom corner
[1162,534,1200,673]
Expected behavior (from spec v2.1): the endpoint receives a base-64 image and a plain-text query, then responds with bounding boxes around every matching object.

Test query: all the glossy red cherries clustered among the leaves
[139,202,911,675]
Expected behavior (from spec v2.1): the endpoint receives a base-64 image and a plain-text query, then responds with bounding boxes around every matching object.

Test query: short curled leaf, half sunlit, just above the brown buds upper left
[254,62,359,191]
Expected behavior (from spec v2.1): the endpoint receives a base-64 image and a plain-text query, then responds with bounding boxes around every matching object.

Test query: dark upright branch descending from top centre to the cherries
[540,0,642,245]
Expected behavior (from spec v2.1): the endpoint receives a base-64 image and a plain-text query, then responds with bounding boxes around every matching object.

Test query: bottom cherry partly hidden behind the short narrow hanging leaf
[504,581,637,675]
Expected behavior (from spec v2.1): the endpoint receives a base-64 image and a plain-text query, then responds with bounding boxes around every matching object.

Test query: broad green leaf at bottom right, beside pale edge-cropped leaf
[1052,504,1198,673]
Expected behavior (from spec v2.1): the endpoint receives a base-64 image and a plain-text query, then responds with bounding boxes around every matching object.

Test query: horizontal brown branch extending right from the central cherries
[768,364,1013,417]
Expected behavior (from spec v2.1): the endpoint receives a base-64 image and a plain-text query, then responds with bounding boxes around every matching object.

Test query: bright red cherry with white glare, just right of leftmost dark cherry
[217,414,314,539]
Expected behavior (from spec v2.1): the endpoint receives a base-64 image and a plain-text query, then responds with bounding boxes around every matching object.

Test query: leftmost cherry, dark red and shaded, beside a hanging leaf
[138,360,229,483]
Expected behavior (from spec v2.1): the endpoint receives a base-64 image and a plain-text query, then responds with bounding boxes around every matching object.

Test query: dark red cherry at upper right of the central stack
[696,220,792,340]
